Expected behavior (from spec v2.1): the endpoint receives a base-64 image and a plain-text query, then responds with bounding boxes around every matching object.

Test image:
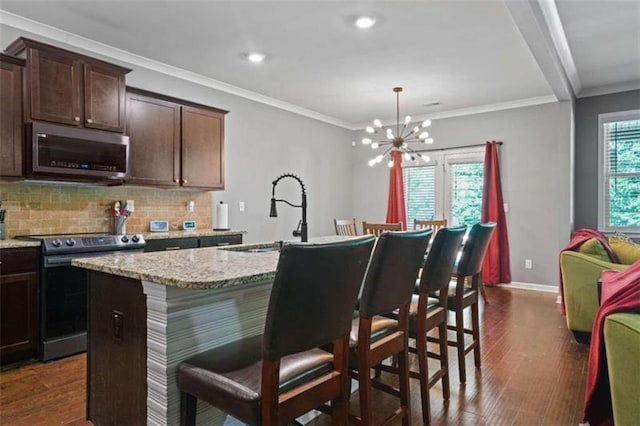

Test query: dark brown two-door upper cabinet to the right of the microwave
[126,89,226,190]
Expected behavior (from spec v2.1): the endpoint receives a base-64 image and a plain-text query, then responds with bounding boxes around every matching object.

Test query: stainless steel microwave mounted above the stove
[27,122,129,180]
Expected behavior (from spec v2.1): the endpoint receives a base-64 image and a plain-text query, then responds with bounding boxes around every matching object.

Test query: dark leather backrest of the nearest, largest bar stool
[263,236,375,360]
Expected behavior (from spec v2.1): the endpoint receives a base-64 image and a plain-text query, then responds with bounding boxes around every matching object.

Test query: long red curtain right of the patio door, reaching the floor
[481,141,511,284]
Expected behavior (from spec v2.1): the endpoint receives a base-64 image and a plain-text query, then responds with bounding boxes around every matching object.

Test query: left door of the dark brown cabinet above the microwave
[29,49,82,126]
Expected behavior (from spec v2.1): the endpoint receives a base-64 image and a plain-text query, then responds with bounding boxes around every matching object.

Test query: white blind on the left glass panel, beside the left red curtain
[402,166,436,229]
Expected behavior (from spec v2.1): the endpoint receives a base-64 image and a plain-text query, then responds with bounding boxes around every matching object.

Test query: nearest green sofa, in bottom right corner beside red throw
[604,313,640,426]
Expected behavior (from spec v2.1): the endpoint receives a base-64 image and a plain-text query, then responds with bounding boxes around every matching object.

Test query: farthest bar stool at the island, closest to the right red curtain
[428,222,496,383]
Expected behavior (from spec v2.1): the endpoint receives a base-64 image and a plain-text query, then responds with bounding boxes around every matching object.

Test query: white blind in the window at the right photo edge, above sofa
[603,120,640,229]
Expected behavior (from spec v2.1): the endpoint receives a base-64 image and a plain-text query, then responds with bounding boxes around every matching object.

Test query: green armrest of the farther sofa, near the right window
[560,251,629,333]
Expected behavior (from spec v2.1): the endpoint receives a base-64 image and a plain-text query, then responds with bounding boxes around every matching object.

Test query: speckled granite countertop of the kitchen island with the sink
[71,236,360,289]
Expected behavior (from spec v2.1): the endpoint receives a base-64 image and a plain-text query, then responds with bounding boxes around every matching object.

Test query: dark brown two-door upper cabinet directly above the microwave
[6,38,130,133]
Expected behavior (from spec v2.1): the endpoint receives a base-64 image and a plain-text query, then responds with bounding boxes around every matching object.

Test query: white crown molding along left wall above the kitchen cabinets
[0,9,353,130]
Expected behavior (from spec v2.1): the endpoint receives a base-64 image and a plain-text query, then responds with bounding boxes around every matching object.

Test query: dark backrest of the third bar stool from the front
[420,226,467,293]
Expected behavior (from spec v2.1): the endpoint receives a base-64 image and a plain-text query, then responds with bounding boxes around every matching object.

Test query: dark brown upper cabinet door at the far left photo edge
[0,58,22,176]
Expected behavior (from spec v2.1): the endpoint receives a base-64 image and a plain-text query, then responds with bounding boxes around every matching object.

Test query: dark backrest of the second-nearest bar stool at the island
[359,229,432,318]
